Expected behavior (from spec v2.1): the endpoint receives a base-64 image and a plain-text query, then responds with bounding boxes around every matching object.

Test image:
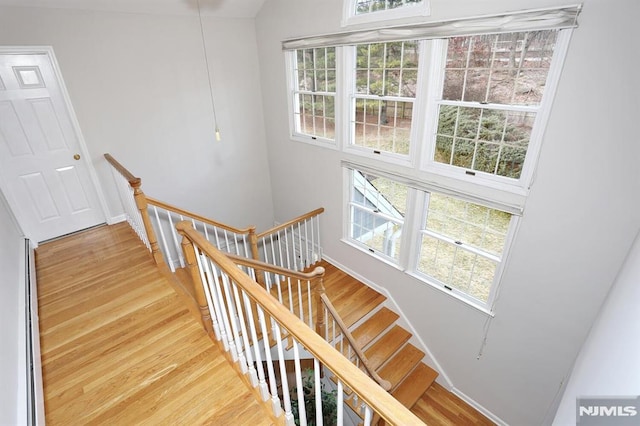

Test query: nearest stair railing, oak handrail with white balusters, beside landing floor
[177,221,423,426]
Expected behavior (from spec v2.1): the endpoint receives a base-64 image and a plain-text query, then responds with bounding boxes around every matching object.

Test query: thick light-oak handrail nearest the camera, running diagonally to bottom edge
[176,221,424,425]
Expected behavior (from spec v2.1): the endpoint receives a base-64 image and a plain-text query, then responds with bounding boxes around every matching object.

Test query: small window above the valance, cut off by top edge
[343,0,429,25]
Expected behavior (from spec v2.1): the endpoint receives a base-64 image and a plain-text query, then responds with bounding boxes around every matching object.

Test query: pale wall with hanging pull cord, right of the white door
[0,7,273,229]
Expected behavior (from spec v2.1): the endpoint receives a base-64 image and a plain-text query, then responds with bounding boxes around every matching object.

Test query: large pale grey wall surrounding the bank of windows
[256,0,640,425]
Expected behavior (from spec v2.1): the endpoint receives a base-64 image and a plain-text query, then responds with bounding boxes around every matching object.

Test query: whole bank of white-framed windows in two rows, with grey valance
[283,5,580,311]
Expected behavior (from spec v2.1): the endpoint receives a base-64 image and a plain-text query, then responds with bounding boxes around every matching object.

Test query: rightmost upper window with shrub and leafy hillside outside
[430,30,557,181]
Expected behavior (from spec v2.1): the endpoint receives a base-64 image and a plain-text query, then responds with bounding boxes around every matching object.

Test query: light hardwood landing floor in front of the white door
[36,223,279,425]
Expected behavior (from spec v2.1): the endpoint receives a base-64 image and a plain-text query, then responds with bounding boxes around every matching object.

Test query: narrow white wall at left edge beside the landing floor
[0,194,26,425]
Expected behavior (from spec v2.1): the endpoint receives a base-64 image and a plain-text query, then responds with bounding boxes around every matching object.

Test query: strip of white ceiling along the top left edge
[0,0,265,18]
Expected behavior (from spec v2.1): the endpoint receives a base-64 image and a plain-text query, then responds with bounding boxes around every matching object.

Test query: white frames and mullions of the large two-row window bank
[286,21,573,315]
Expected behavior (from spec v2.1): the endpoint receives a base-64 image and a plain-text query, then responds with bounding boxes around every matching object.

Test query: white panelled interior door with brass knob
[0,54,105,242]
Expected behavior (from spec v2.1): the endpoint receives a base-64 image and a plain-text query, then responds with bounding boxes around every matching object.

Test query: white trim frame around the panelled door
[0,46,109,243]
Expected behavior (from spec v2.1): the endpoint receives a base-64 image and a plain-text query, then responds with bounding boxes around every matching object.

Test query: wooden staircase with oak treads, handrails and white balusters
[105,154,437,425]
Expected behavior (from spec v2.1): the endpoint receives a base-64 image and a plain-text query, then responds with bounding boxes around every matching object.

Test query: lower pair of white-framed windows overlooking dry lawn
[347,165,516,310]
